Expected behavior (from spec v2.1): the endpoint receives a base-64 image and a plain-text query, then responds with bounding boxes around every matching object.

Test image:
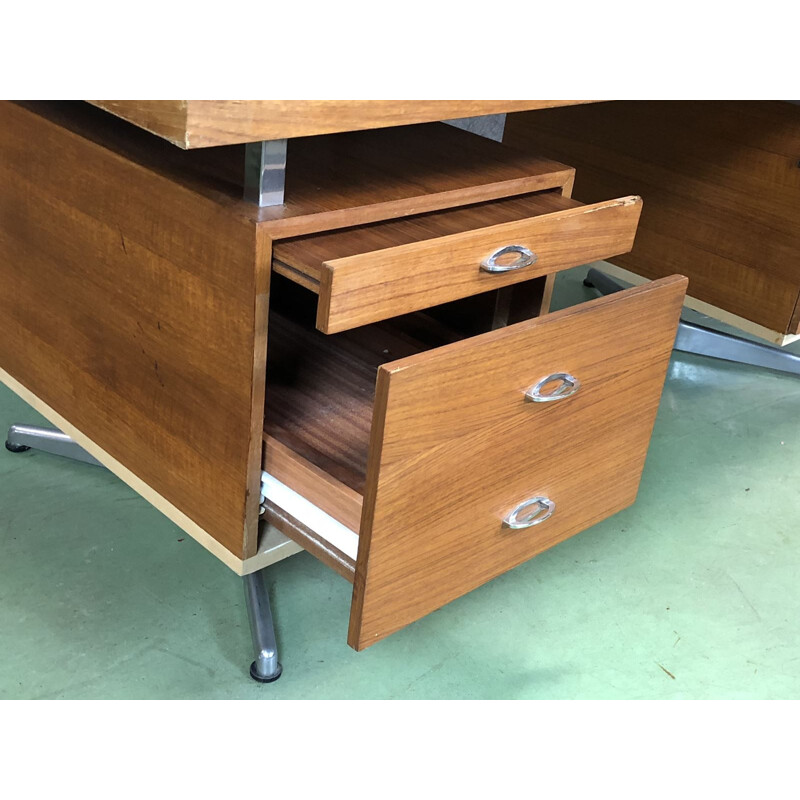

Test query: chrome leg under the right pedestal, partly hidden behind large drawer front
[583,267,800,375]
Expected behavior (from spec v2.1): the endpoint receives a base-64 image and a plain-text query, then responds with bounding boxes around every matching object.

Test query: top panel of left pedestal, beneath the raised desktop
[25,102,573,239]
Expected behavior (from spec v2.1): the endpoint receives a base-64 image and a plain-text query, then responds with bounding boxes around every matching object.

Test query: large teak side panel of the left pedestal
[0,103,270,559]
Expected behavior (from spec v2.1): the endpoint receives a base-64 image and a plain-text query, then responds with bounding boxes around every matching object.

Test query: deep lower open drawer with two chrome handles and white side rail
[264,276,687,649]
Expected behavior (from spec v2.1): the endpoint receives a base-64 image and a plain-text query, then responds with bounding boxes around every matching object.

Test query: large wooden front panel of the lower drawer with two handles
[349,276,686,649]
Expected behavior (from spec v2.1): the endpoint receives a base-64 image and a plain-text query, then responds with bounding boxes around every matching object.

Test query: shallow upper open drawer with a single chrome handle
[273,191,642,333]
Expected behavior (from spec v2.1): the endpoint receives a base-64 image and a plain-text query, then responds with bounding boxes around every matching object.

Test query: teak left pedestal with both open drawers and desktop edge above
[0,101,685,649]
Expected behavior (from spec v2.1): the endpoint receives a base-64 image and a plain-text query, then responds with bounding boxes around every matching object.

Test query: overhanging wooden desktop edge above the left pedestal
[89,100,587,148]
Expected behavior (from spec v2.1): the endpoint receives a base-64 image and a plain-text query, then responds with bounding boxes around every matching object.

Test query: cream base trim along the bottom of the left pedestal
[0,367,302,575]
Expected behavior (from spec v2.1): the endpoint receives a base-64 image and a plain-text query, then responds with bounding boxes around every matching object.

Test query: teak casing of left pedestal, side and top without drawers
[0,102,574,570]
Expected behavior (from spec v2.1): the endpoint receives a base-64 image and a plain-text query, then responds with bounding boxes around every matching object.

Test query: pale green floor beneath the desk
[0,268,800,700]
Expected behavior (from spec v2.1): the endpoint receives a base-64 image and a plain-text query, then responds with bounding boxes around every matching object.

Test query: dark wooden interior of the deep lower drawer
[264,280,476,496]
